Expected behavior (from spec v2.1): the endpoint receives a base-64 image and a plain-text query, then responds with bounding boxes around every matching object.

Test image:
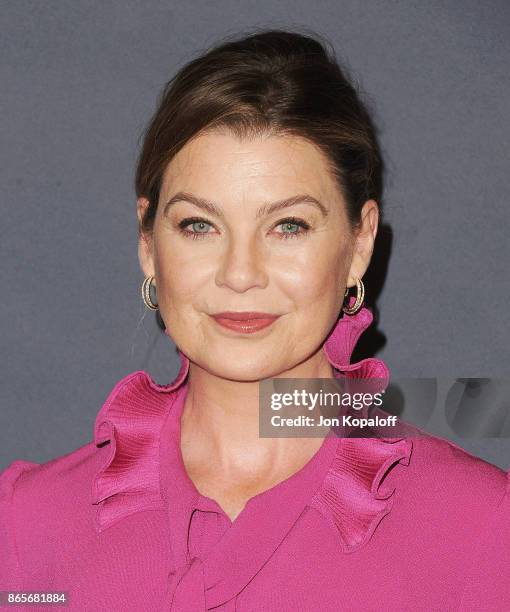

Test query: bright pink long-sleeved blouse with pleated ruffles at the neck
[0,308,510,612]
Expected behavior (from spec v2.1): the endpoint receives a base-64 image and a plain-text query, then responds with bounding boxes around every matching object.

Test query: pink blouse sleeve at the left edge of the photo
[0,459,39,591]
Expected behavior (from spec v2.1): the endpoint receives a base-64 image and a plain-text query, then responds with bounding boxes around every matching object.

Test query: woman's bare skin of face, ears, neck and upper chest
[137,131,379,521]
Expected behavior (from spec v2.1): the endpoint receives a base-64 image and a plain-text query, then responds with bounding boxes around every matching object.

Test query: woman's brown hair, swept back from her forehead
[135,30,383,235]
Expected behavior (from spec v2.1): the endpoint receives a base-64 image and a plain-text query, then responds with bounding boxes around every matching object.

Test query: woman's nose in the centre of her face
[216,234,268,293]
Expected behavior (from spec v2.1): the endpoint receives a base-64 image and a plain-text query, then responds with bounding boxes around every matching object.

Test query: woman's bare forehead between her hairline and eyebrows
[163,131,336,193]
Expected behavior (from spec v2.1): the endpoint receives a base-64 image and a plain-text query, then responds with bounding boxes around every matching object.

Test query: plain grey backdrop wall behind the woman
[0,0,510,469]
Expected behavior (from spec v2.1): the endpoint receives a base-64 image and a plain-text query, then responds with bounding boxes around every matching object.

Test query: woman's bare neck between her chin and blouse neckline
[181,350,334,483]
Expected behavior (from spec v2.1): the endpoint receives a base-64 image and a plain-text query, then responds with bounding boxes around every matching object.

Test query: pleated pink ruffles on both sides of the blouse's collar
[92,298,412,572]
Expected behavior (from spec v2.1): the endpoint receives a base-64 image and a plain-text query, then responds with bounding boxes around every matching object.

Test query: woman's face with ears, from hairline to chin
[138,132,377,381]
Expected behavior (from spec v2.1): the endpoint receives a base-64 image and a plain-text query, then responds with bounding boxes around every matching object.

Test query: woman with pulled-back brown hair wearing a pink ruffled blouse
[0,31,510,612]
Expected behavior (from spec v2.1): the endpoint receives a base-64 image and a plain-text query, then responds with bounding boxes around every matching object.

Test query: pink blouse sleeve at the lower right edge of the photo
[459,470,510,612]
